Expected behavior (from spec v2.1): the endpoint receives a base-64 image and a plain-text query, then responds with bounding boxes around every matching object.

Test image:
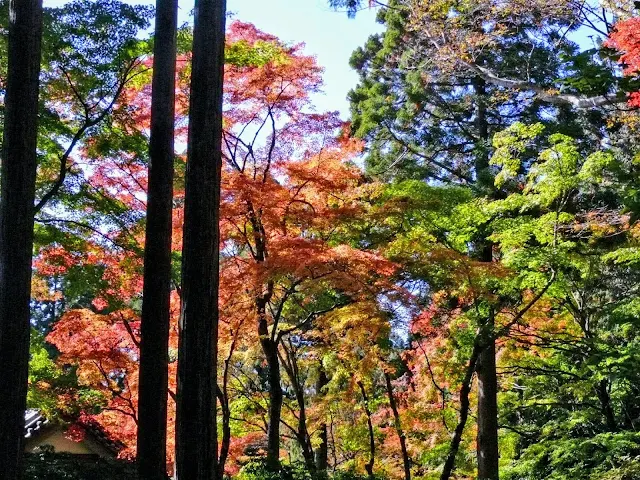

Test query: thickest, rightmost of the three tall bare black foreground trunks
[176,0,226,480]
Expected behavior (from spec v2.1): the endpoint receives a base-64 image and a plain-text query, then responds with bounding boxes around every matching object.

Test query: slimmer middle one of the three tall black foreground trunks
[137,0,178,480]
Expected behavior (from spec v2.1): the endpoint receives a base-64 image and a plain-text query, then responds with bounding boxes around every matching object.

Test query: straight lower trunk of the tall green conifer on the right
[476,338,499,480]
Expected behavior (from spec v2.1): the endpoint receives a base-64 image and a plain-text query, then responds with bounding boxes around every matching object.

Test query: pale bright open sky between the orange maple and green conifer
[44,0,381,118]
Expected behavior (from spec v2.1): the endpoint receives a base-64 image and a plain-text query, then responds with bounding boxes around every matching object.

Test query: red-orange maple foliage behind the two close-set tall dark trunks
[41,22,394,472]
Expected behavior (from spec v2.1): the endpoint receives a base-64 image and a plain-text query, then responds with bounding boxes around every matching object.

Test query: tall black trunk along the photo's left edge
[0,0,42,480]
